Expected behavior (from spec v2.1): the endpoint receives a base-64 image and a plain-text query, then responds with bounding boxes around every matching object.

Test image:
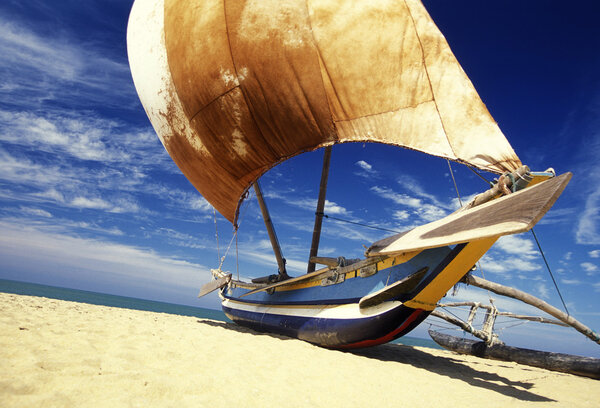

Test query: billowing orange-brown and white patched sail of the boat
[128,0,521,222]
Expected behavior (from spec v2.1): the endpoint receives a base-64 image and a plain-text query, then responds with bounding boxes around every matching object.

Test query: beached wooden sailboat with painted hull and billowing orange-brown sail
[127,0,571,349]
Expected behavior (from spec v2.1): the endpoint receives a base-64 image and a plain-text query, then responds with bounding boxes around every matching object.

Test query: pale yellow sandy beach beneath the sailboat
[0,293,600,408]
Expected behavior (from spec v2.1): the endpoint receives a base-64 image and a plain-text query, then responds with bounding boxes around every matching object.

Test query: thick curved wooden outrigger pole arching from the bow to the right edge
[462,275,600,344]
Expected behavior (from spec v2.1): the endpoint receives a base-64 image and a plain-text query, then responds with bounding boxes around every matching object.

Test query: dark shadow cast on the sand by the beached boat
[198,320,555,402]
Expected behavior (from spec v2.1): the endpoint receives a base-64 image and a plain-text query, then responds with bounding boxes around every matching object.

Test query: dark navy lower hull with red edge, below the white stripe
[223,304,430,349]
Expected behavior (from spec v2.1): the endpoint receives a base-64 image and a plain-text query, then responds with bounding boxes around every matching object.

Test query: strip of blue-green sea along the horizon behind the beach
[0,279,441,349]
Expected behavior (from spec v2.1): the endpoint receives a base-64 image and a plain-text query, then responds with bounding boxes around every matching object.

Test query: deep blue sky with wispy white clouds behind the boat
[0,0,600,356]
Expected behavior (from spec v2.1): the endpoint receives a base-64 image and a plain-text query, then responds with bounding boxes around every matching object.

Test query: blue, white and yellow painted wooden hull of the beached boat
[220,239,495,349]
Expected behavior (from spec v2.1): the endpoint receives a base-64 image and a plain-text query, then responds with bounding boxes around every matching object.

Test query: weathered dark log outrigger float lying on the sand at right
[429,330,600,379]
